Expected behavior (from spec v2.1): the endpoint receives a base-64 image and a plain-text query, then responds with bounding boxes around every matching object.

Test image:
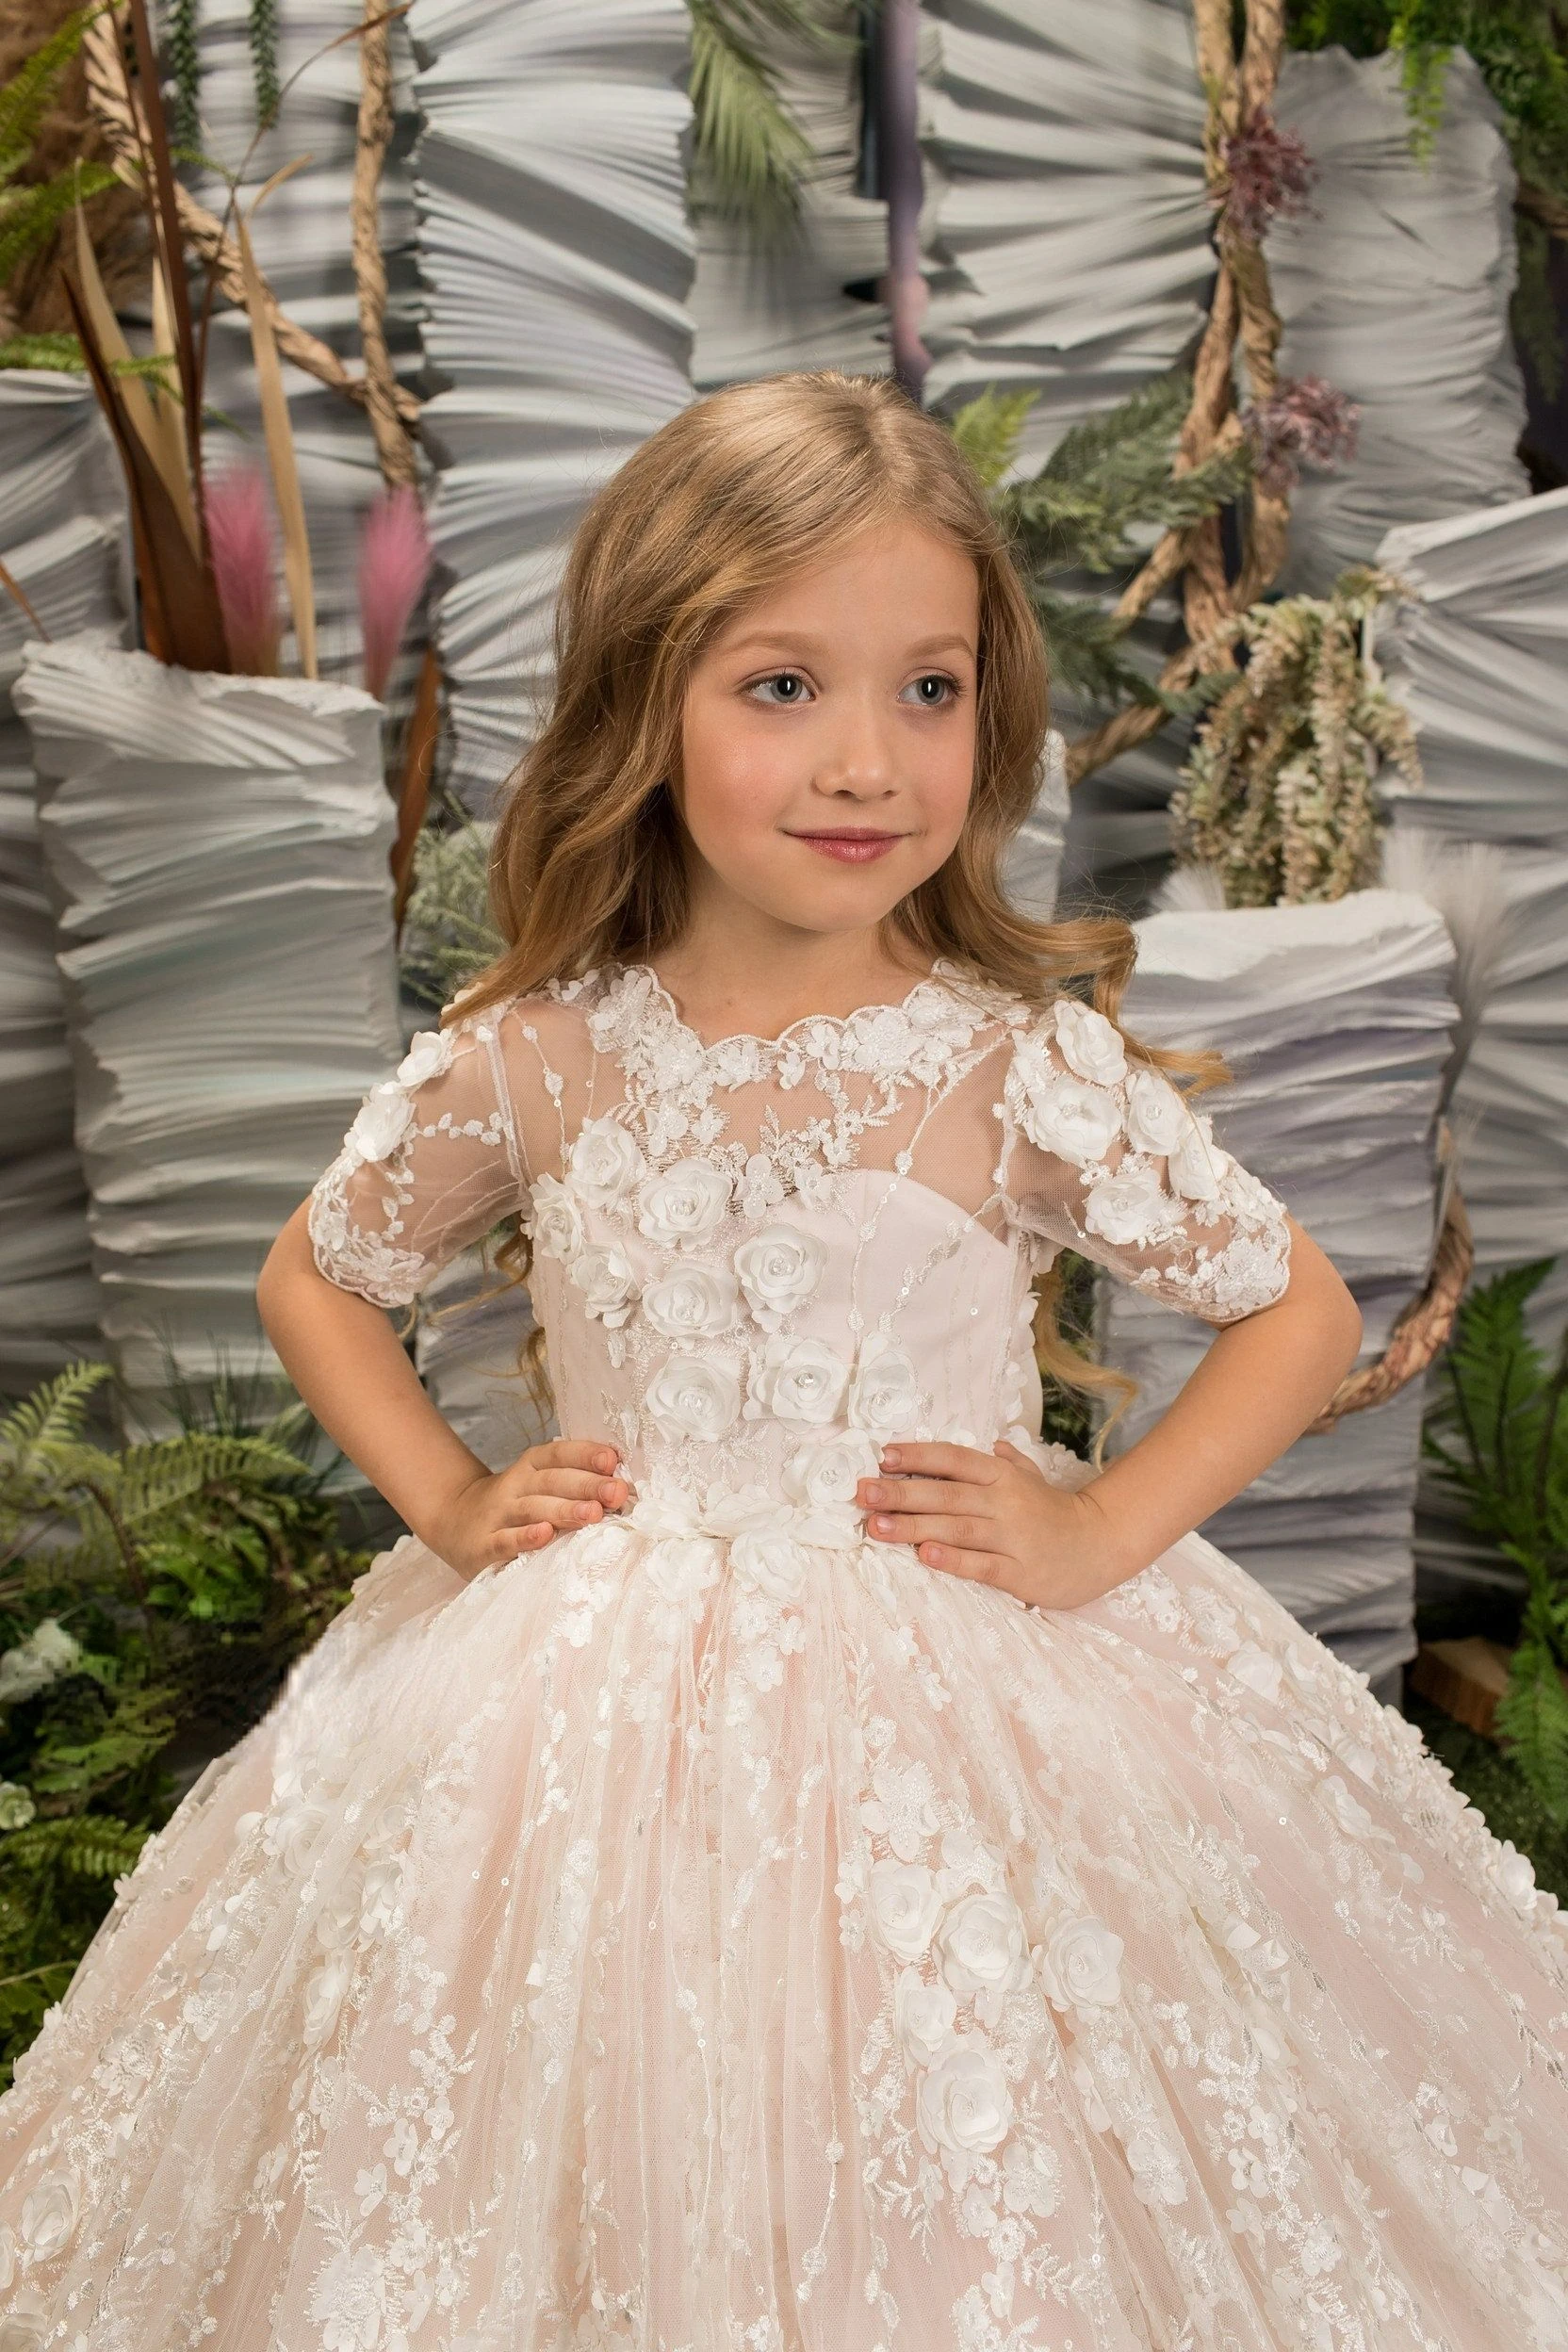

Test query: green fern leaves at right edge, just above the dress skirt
[1422,1258,1568,1827]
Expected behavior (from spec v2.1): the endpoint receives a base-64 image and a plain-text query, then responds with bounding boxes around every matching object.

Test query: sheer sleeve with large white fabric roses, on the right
[997,997,1291,1324]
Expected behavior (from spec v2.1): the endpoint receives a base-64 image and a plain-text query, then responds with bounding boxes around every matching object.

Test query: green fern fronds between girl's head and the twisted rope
[950,371,1250,715]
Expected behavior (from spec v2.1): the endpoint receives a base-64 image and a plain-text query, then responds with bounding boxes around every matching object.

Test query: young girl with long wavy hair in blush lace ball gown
[0,374,1568,2352]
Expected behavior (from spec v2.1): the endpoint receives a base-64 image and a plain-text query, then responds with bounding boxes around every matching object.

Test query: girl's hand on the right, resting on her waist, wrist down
[856,1437,1128,1609]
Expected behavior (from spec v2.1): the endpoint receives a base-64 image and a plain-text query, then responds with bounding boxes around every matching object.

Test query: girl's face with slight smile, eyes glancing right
[672,522,980,931]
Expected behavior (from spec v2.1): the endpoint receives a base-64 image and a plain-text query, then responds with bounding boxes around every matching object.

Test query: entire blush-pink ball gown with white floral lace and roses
[0,967,1568,2352]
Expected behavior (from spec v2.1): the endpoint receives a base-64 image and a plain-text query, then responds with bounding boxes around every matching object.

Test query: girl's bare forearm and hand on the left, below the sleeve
[256,1201,630,1576]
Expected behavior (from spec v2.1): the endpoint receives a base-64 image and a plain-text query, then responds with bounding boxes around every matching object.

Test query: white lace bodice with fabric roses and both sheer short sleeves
[310,964,1288,1505]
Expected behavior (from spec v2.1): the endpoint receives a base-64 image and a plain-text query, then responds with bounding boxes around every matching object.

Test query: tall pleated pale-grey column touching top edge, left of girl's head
[412,0,695,809]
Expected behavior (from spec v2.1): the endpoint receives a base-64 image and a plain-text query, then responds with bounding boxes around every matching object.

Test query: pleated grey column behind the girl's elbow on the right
[1101,891,1455,1674]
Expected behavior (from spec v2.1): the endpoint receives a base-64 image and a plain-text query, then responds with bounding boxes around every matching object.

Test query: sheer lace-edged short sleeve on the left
[308,1019,527,1308]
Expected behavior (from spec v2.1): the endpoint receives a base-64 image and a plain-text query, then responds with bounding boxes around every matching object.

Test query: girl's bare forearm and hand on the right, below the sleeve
[860,1218,1361,1609]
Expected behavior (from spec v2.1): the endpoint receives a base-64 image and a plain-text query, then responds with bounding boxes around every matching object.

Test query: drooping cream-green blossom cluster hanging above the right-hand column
[1170,564,1422,906]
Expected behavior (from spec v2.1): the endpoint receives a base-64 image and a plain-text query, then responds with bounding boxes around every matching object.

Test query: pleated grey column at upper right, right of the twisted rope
[1267,49,1528,595]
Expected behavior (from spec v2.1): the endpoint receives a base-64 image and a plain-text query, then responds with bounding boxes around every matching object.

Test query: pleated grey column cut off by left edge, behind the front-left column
[0,369,120,1395]
